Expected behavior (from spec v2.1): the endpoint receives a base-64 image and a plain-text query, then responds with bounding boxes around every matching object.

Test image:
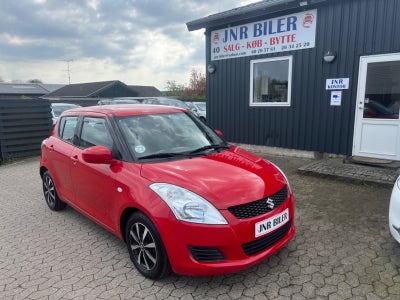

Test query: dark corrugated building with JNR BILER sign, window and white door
[187,0,400,160]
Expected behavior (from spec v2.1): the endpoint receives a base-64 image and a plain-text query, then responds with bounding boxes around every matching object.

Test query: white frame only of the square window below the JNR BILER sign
[249,55,293,107]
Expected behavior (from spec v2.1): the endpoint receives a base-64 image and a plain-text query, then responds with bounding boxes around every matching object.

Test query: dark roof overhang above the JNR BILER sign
[186,0,328,31]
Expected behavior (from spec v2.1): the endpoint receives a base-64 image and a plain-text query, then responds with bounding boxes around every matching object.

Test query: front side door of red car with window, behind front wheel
[71,116,119,231]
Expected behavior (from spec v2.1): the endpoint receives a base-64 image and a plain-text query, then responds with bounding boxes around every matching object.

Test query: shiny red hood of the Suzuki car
[141,146,286,209]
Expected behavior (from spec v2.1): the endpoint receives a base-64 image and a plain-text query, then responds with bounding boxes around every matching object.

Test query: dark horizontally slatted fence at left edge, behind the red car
[0,99,53,163]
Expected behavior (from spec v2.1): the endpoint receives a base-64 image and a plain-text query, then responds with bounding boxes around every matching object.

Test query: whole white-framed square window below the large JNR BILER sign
[250,56,292,106]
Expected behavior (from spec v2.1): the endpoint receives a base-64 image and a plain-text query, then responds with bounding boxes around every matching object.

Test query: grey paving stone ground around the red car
[0,156,400,300]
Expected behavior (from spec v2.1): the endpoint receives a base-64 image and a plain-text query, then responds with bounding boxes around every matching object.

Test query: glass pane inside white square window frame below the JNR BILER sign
[253,60,289,103]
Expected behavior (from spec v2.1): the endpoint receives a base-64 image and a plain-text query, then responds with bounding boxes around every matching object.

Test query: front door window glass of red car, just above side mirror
[80,117,113,150]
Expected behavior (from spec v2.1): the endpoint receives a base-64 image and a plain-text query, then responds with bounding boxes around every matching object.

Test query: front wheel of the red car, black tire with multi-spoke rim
[125,212,171,279]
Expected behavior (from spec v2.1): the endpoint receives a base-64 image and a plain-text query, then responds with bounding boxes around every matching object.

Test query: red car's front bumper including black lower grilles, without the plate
[158,193,295,276]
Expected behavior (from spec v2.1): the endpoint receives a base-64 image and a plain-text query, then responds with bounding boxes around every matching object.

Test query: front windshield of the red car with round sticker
[118,112,229,159]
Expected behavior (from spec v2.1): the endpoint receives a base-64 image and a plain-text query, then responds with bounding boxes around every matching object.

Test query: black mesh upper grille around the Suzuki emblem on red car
[228,185,288,219]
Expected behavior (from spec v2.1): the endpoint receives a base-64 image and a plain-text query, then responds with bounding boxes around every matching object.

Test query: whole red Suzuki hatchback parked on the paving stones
[40,104,295,279]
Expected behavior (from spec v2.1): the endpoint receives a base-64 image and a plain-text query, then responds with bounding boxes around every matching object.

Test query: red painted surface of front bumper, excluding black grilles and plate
[157,195,295,276]
